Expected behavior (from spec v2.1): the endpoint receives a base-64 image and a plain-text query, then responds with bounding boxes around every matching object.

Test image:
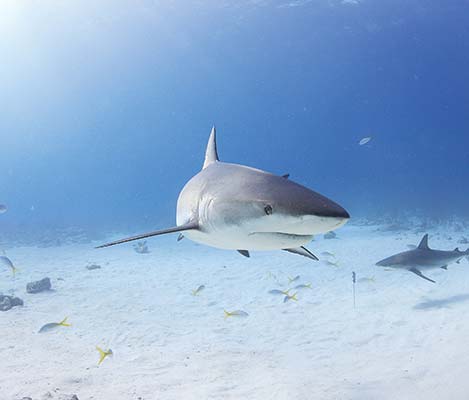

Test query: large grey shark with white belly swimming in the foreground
[98,127,350,260]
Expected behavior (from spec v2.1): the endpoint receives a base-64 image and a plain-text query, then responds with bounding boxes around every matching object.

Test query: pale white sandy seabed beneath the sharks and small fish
[0,226,469,400]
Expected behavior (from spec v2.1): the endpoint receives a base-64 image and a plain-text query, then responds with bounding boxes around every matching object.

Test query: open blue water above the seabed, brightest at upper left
[0,0,469,234]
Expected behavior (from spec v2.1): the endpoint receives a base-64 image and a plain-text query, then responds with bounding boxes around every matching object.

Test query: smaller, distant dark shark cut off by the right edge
[376,234,469,283]
